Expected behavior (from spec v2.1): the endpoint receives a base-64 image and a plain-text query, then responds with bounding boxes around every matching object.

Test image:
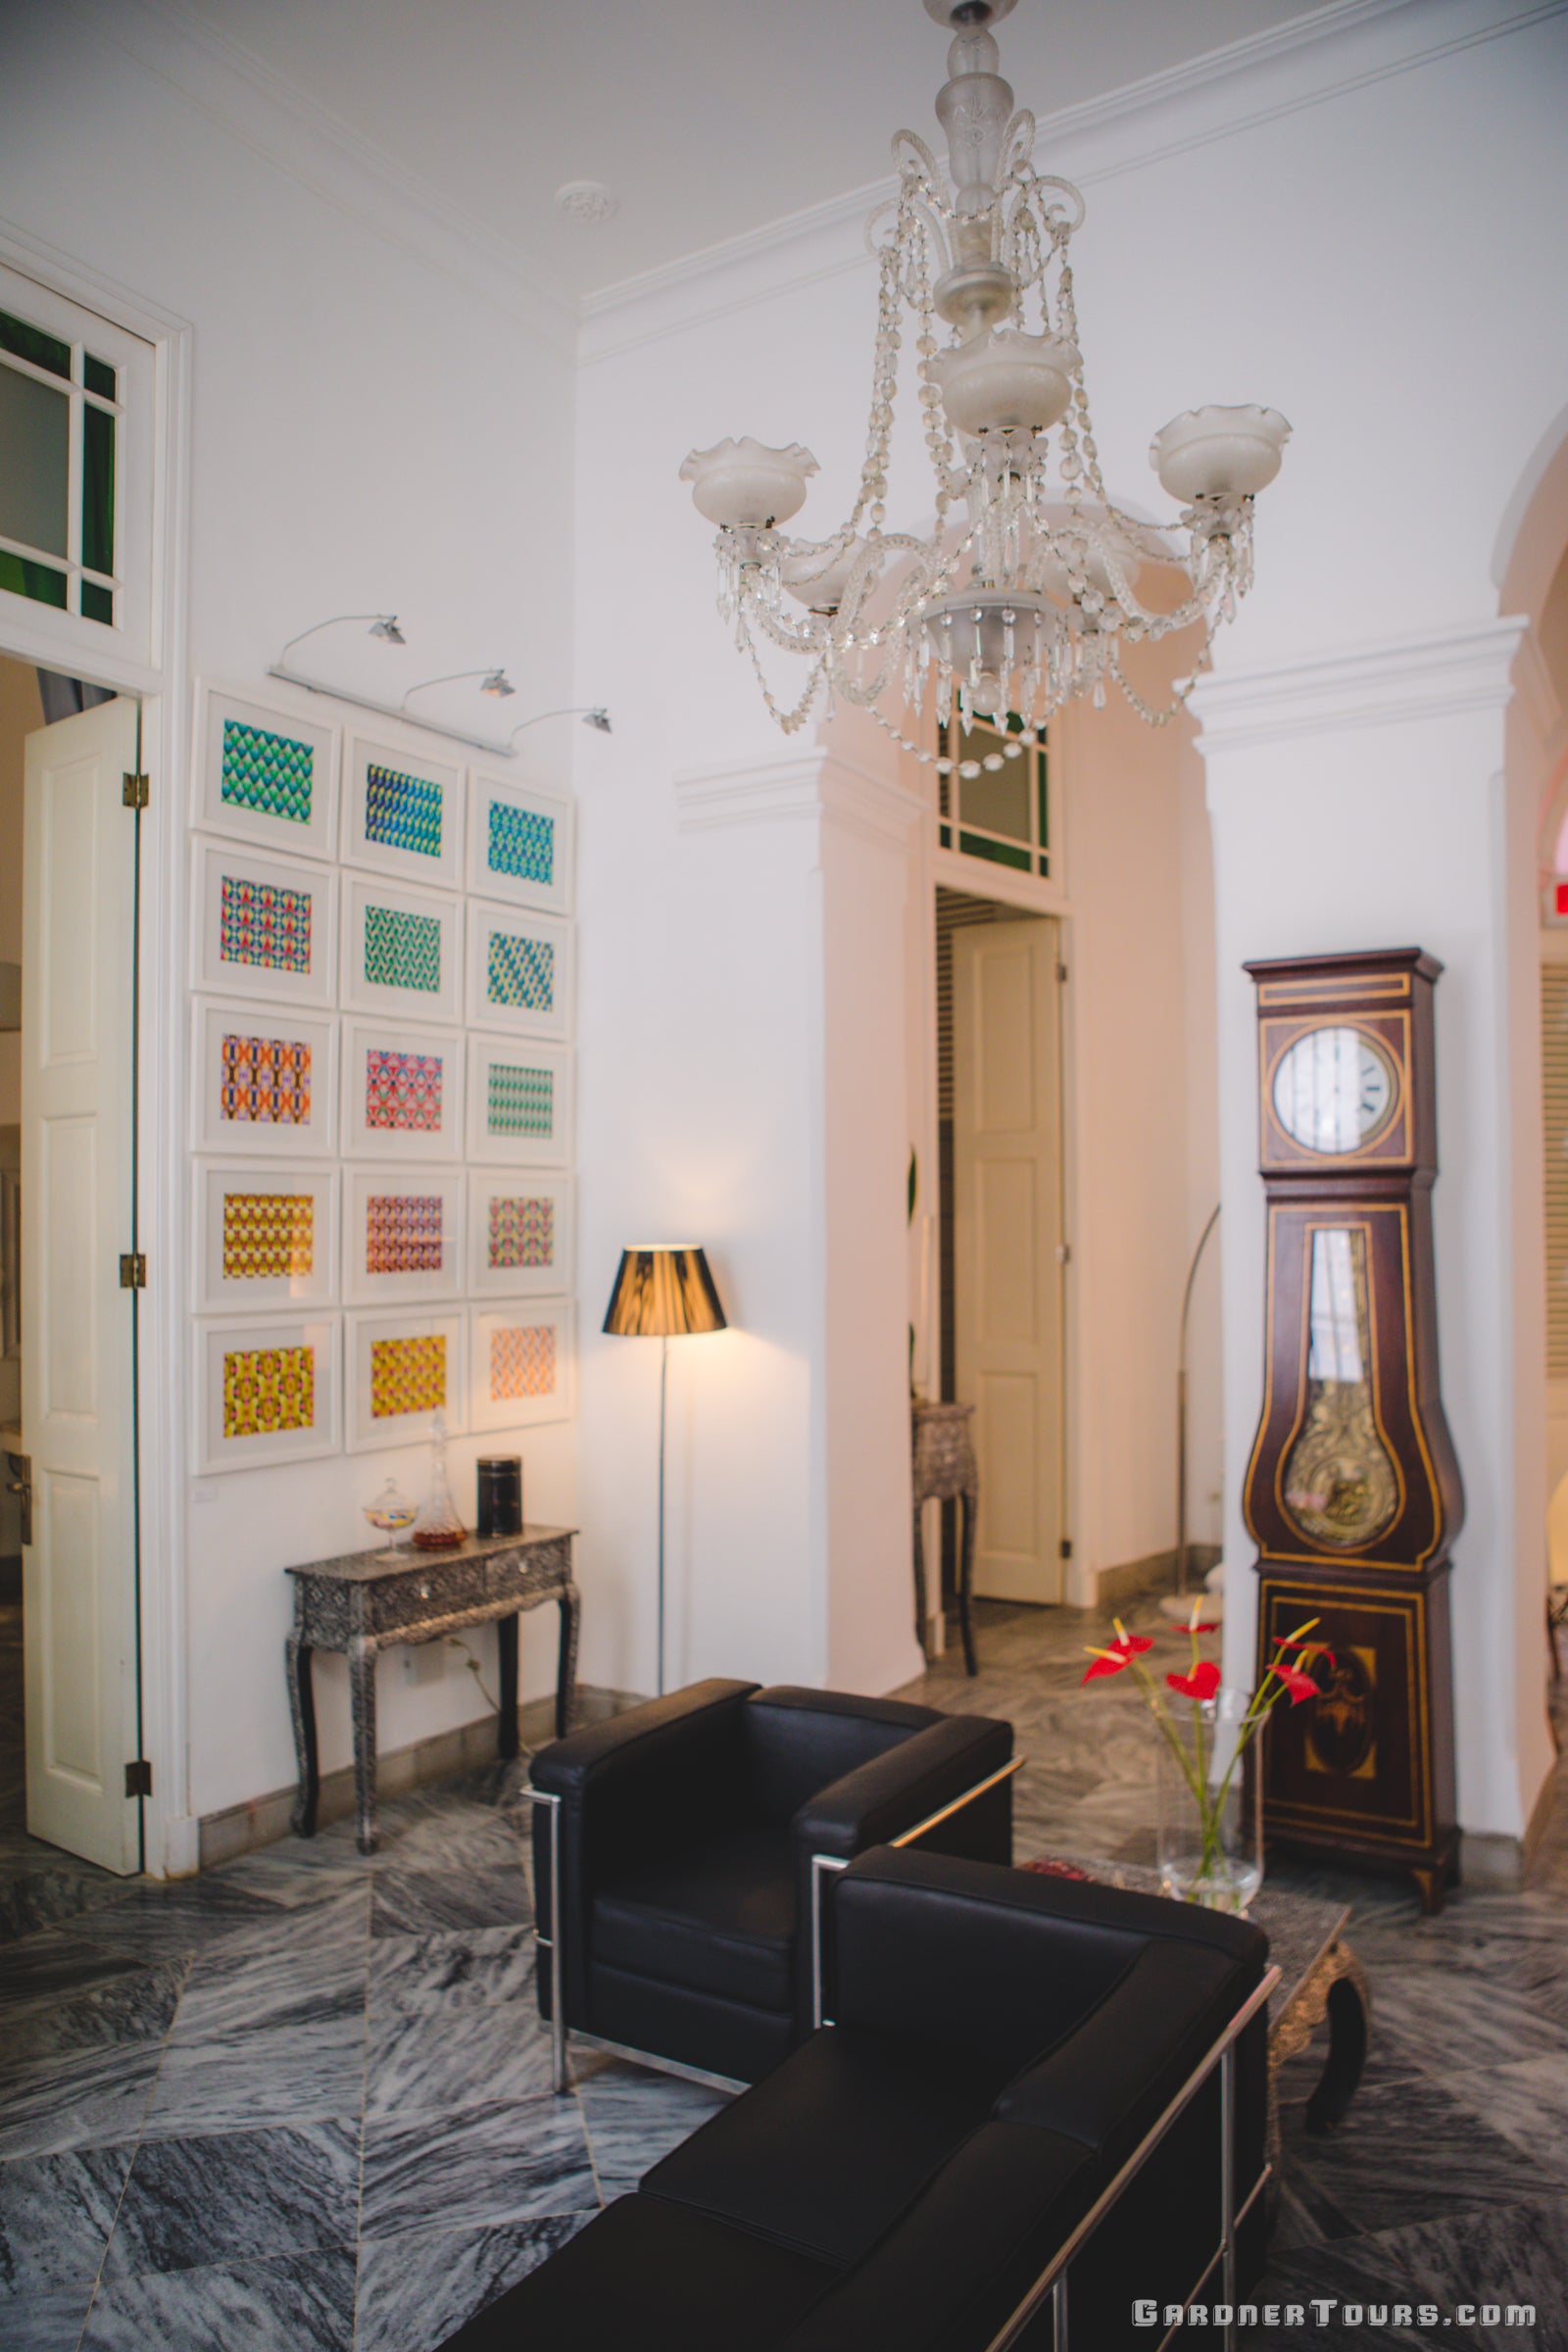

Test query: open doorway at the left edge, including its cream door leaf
[0,657,143,1875]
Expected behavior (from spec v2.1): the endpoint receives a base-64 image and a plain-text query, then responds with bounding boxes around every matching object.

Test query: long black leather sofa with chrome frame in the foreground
[447,1846,1267,2352]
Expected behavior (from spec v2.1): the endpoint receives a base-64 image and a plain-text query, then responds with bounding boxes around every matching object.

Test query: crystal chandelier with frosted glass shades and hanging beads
[682,0,1291,774]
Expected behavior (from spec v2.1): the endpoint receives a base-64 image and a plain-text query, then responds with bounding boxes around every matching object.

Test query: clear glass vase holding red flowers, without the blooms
[1154,1689,1267,1912]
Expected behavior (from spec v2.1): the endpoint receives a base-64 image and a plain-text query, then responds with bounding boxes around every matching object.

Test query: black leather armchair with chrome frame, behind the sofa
[531,1680,1013,2091]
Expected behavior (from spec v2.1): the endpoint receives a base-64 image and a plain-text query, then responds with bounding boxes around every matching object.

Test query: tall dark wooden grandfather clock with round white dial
[1242,948,1464,1910]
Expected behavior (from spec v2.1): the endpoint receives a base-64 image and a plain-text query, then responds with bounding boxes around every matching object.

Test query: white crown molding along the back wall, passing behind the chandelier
[581,0,1568,363]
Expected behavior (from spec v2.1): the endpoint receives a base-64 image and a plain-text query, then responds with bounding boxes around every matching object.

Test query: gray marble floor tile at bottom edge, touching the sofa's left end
[355,2213,592,2352]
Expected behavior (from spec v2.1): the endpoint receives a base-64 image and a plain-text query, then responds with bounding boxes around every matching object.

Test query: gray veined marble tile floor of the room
[0,1609,1568,2352]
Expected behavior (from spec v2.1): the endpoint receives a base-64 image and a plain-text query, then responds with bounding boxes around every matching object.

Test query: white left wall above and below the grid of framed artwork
[0,0,582,1816]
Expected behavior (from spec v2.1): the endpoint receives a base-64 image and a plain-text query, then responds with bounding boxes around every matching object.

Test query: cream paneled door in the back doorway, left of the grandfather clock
[953,915,1062,1601]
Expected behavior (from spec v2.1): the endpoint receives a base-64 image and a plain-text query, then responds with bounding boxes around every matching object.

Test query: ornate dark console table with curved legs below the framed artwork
[287,1527,581,1853]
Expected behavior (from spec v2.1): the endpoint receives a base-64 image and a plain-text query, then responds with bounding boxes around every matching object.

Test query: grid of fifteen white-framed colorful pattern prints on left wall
[190,684,576,1475]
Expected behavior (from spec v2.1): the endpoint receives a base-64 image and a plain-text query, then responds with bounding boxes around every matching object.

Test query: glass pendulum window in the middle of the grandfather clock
[1279,1225,1398,1552]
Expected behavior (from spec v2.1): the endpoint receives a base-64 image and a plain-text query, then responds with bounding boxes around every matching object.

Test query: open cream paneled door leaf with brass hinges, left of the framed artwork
[22,699,139,1872]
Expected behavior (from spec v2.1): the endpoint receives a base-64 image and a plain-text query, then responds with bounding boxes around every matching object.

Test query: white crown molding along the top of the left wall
[69,0,578,360]
